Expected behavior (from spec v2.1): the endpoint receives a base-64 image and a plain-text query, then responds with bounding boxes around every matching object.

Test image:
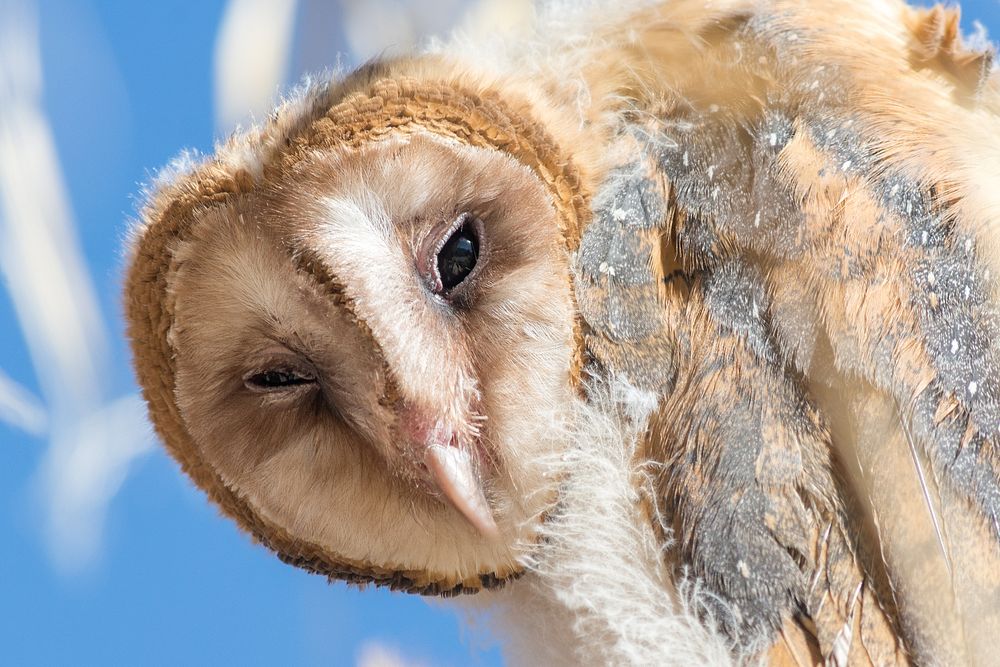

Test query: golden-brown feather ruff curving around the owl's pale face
[125,64,589,595]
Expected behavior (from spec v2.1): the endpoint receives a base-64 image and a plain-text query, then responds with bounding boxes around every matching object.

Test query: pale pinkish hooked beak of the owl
[424,444,500,540]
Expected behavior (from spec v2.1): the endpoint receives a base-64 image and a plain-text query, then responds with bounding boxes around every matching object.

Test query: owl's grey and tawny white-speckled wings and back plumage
[576,3,1000,664]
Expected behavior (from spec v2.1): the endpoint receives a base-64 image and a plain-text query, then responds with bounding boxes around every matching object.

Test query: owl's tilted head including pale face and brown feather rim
[125,60,586,593]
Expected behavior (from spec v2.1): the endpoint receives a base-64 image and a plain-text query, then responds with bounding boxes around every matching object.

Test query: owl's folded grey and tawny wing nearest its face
[576,145,901,664]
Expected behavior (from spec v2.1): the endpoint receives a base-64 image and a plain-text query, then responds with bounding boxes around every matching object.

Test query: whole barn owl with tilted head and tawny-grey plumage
[125,0,1000,665]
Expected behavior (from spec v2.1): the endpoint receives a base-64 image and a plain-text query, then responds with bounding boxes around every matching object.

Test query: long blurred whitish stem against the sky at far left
[0,0,150,571]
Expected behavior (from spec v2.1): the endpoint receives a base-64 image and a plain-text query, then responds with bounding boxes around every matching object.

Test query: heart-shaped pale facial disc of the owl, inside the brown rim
[167,131,574,589]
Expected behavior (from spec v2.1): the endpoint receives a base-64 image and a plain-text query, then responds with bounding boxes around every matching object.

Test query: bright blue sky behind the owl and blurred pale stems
[0,0,1000,665]
